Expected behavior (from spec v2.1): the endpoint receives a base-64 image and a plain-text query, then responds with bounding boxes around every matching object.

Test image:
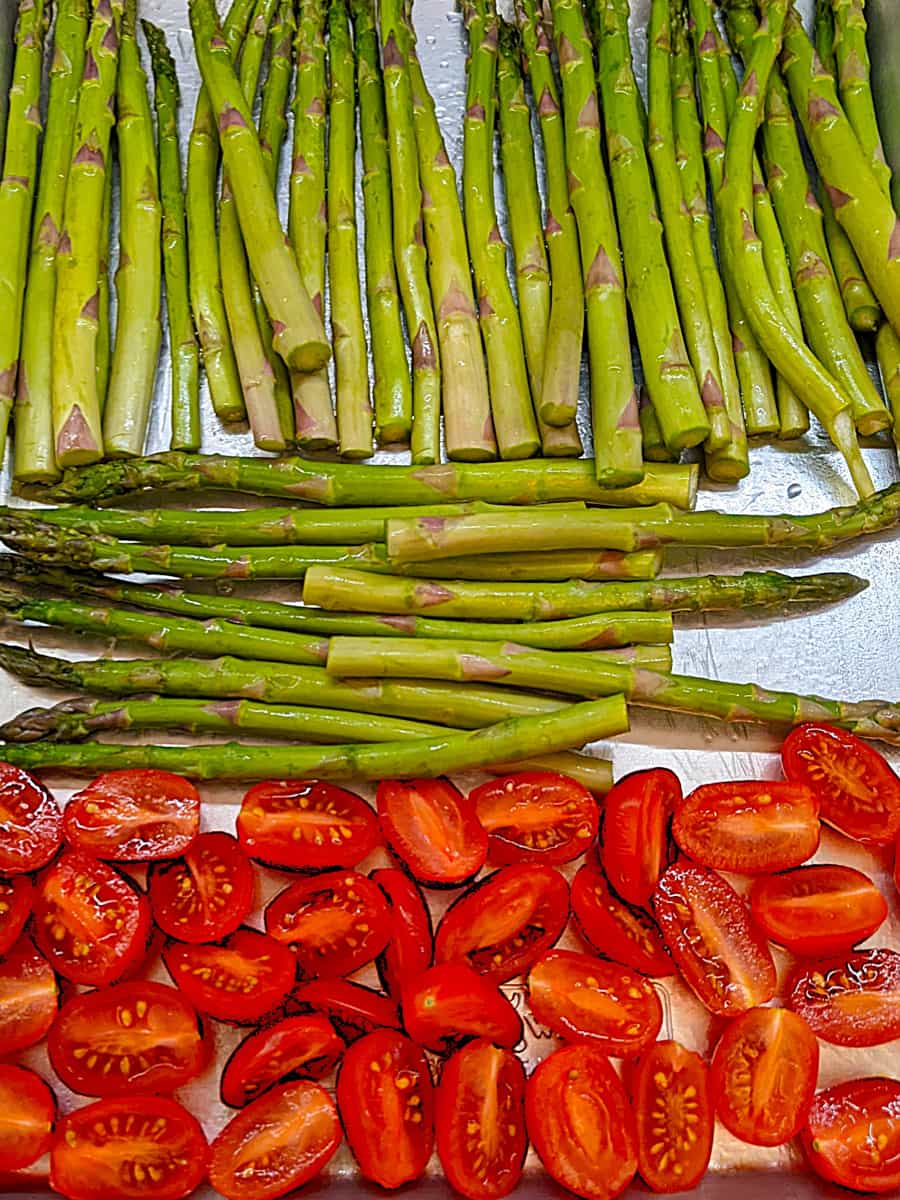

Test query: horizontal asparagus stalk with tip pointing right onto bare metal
[304,566,868,620]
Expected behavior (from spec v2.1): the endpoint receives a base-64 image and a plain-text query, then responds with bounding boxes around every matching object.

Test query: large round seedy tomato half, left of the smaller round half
[35,850,150,986]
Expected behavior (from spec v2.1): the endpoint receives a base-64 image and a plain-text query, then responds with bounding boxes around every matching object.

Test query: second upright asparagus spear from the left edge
[12,0,88,482]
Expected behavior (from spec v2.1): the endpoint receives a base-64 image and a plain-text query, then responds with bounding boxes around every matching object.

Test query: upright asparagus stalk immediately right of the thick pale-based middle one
[465,0,540,460]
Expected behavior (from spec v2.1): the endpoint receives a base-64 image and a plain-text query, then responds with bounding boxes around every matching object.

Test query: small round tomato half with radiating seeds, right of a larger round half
[146,833,256,942]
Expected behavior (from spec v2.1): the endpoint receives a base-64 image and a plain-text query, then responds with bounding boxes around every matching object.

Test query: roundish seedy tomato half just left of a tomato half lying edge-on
[265,871,391,978]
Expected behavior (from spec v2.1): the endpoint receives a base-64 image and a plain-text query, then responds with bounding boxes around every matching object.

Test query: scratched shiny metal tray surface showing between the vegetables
[0,0,900,1200]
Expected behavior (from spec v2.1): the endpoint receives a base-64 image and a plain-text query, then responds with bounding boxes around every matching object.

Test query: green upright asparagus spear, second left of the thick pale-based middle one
[350,0,413,445]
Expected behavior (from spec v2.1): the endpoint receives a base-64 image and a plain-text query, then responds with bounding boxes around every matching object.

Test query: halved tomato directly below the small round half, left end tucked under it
[163,929,296,1025]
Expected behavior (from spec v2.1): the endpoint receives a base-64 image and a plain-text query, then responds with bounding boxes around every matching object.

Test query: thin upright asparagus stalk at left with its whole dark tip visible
[140,20,200,450]
